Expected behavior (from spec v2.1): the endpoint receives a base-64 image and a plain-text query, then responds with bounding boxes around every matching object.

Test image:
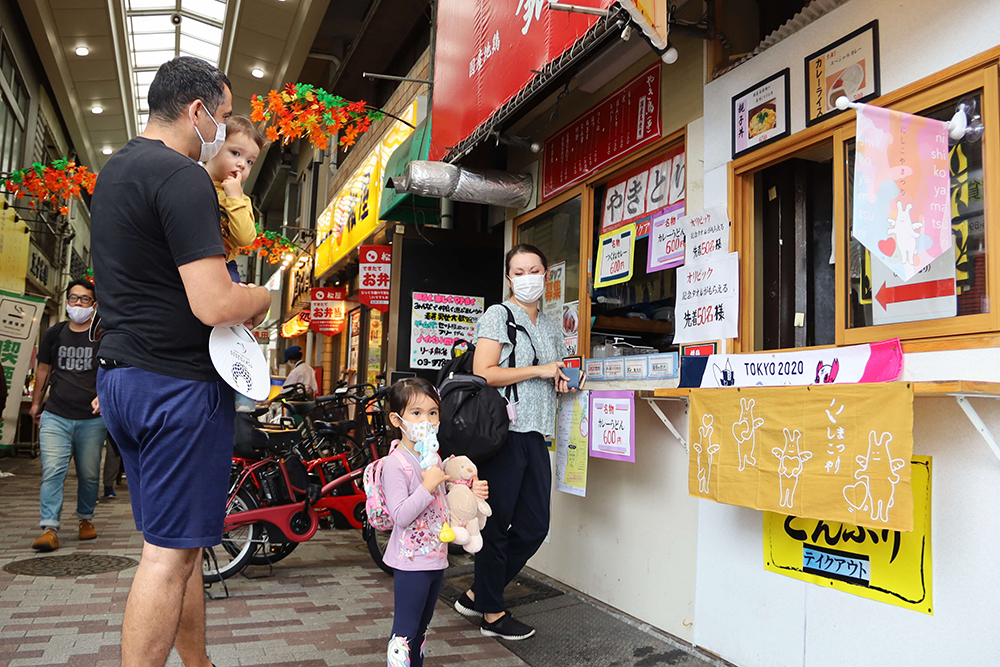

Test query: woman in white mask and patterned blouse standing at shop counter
[455,244,569,640]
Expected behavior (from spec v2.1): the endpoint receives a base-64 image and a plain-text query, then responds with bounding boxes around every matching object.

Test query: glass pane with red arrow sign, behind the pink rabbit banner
[844,91,989,329]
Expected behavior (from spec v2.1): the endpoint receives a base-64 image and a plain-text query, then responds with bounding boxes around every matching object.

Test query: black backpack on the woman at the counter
[437,305,537,463]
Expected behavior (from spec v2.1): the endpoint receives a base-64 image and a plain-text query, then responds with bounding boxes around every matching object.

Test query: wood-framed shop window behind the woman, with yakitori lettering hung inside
[515,139,687,366]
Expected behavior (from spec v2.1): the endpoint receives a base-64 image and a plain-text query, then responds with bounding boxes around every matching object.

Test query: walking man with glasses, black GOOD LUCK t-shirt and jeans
[31,280,108,551]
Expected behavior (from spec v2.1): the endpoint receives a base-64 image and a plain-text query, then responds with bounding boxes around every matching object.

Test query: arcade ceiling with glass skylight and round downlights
[12,0,330,170]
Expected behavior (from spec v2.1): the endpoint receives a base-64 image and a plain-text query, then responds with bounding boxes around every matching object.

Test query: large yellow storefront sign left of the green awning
[316,101,417,278]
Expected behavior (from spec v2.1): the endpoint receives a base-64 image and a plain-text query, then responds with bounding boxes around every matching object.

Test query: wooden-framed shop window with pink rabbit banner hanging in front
[730,58,1000,352]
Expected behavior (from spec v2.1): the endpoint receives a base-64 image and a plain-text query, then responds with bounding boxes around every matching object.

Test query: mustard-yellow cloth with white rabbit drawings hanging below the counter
[688,383,913,532]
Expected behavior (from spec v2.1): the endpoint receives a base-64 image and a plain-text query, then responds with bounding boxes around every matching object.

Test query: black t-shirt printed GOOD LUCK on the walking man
[38,322,100,419]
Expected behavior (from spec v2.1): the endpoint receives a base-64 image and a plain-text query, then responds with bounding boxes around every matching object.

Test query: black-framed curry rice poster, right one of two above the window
[805,20,881,126]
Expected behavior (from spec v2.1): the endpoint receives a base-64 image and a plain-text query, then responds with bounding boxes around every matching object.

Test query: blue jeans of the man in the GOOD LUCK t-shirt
[38,412,108,528]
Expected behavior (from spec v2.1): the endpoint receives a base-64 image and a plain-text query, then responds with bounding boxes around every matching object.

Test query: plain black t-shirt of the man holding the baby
[90,137,224,380]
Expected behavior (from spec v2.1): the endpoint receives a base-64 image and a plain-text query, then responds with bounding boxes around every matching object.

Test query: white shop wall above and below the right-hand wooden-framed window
[693,0,1000,667]
